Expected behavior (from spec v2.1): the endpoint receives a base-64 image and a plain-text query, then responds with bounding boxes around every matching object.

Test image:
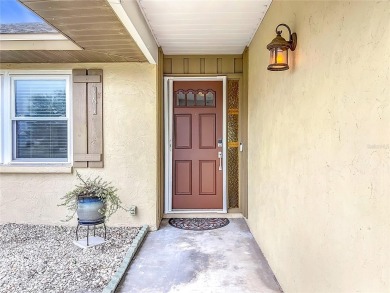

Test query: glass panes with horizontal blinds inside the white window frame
[13,79,68,159]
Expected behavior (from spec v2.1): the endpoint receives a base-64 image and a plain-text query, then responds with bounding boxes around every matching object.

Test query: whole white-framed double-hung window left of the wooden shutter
[3,75,70,163]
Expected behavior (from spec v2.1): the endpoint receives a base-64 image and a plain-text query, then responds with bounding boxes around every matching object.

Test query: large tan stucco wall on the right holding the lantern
[248,1,390,293]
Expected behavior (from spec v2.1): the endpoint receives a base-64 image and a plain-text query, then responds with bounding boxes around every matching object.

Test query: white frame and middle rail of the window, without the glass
[0,70,73,166]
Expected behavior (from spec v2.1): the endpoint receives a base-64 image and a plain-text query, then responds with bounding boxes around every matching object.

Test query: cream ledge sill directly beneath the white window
[0,165,72,174]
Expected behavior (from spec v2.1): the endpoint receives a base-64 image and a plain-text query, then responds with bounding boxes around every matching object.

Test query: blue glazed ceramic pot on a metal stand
[77,197,104,225]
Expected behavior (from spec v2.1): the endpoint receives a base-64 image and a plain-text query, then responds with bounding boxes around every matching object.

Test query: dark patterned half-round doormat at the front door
[169,218,230,231]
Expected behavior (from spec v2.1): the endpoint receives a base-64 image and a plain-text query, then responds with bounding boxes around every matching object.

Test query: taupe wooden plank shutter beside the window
[73,69,103,168]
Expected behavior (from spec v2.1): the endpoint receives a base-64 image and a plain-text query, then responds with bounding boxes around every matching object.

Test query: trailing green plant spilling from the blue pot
[59,171,129,221]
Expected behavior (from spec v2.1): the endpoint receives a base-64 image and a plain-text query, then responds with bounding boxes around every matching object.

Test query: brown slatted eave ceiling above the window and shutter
[0,0,147,63]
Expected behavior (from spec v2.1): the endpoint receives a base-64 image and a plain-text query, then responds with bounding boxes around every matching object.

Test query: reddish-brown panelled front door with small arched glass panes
[172,81,223,209]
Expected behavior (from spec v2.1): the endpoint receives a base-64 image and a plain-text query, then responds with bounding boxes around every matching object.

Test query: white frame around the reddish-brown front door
[164,76,227,214]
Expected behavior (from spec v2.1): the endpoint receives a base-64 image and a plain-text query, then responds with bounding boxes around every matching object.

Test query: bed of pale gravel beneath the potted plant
[0,224,140,293]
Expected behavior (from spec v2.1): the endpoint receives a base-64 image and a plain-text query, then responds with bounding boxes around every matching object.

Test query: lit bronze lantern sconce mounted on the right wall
[267,23,297,71]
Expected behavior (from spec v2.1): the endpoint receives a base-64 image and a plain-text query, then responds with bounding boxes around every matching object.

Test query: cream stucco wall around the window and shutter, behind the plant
[0,63,157,228]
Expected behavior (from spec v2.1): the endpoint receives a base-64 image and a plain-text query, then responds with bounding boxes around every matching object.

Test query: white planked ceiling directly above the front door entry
[137,0,272,55]
